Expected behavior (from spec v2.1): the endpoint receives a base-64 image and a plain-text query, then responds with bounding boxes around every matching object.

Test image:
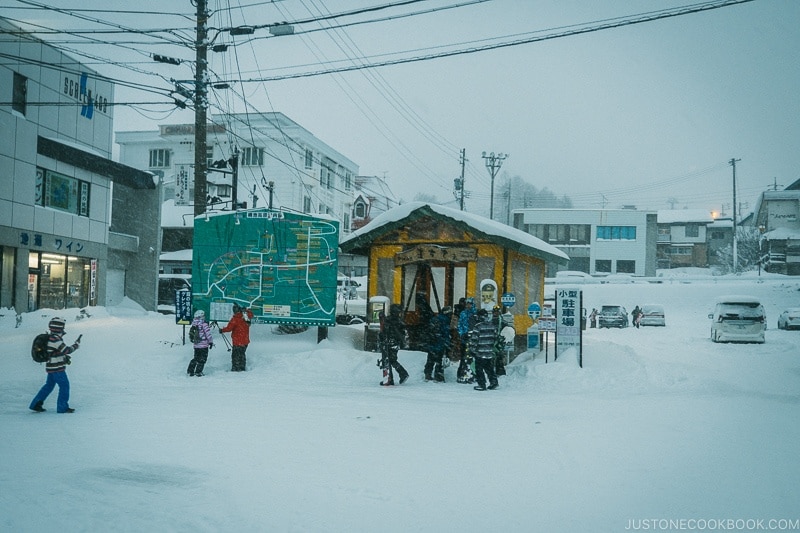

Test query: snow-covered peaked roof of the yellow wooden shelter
[339,202,569,264]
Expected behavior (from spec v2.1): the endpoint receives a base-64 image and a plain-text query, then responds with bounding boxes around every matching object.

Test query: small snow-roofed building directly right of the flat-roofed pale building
[656,209,714,268]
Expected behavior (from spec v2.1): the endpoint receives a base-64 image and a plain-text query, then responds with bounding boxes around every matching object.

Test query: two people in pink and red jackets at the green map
[186,304,253,377]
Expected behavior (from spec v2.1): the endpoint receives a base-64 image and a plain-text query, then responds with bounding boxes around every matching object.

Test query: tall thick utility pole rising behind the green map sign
[194,0,208,216]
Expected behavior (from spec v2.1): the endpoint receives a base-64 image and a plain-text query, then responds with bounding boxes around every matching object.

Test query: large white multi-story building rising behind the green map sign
[116,113,358,251]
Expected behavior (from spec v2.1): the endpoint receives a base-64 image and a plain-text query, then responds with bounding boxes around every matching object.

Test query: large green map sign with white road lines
[192,209,339,326]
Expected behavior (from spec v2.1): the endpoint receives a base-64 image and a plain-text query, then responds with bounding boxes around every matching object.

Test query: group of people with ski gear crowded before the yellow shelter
[381,297,506,391]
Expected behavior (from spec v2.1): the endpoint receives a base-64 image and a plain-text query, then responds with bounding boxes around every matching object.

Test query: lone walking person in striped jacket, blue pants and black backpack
[29,317,81,413]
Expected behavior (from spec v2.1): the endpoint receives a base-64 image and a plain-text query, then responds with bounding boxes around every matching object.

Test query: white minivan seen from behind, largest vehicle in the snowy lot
[708,296,767,343]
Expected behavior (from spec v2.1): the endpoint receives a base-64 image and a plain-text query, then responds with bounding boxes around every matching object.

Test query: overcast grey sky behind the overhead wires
[0,0,800,214]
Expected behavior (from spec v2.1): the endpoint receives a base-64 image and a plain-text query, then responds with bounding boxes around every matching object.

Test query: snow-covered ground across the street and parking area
[0,276,800,532]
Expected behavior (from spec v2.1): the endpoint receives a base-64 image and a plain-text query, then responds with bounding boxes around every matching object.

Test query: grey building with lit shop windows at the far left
[0,19,158,313]
